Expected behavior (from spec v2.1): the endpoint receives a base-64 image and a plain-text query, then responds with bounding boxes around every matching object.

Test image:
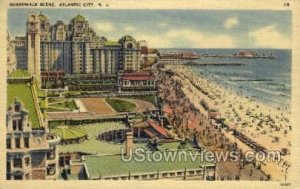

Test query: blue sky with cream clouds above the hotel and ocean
[7,9,292,49]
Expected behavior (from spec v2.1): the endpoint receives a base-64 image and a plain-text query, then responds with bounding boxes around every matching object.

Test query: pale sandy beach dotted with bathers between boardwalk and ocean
[158,65,292,179]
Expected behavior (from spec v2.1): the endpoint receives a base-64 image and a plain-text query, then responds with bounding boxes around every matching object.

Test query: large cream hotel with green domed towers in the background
[14,13,142,84]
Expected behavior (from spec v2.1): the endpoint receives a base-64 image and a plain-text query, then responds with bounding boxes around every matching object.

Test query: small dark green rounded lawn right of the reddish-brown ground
[105,98,136,112]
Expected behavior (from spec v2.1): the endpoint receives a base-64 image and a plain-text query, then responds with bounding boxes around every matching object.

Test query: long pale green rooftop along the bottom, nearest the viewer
[85,152,214,178]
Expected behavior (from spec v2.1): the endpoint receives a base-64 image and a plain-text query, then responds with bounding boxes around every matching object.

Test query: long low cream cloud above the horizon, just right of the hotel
[136,28,236,48]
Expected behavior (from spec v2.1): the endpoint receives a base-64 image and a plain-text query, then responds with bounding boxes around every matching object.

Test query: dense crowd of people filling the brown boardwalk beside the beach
[158,69,270,180]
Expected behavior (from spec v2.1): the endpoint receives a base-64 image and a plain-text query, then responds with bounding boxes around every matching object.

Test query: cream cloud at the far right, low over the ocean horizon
[249,25,291,49]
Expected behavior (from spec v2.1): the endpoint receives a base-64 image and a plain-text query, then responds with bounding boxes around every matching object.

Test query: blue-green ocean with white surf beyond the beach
[160,49,291,110]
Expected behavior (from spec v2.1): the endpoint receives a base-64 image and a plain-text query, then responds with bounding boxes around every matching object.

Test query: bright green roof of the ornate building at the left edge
[7,83,40,128]
